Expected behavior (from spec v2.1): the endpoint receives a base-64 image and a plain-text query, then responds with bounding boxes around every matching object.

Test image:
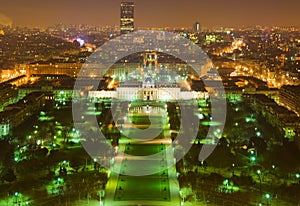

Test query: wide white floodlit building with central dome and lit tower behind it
[89,51,209,101]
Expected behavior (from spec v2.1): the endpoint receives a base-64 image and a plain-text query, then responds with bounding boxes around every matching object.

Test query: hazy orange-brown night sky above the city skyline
[0,0,300,27]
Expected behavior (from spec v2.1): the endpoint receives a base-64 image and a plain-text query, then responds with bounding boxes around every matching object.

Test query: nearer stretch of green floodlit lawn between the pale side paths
[115,144,170,201]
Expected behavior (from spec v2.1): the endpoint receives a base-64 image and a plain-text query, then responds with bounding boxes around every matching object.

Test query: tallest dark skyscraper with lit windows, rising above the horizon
[120,2,134,34]
